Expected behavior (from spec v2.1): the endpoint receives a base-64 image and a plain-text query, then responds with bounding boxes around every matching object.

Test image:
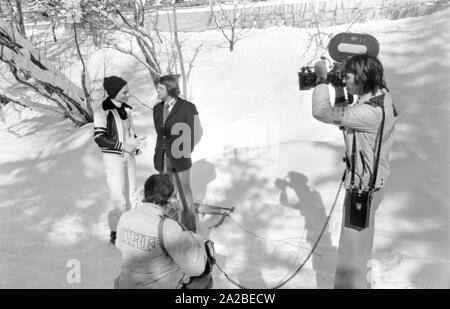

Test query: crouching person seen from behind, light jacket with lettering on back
[114,174,207,289]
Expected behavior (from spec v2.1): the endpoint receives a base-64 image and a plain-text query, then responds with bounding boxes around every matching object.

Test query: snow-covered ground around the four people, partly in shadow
[0,10,450,288]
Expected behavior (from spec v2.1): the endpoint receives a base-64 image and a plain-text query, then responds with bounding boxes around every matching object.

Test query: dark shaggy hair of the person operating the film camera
[344,54,387,94]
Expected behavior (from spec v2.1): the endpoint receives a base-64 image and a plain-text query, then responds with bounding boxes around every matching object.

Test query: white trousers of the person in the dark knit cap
[103,153,138,231]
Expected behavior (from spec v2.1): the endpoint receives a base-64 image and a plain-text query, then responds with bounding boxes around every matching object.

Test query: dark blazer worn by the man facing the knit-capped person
[153,98,202,173]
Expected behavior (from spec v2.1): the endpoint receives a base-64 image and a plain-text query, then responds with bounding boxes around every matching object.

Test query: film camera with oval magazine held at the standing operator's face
[298,32,380,90]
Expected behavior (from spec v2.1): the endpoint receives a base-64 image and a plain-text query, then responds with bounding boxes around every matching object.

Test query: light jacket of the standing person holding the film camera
[312,84,396,188]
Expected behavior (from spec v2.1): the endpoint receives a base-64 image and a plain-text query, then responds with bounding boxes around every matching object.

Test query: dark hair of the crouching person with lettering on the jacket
[143,174,174,206]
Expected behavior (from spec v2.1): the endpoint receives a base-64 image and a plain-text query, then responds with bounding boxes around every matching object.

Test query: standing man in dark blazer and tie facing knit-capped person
[153,75,203,232]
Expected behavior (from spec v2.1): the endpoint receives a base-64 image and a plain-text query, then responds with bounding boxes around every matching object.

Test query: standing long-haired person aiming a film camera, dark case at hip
[312,55,397,289]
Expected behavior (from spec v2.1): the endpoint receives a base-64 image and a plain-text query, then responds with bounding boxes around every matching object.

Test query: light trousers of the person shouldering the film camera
[334,189,384,289]
